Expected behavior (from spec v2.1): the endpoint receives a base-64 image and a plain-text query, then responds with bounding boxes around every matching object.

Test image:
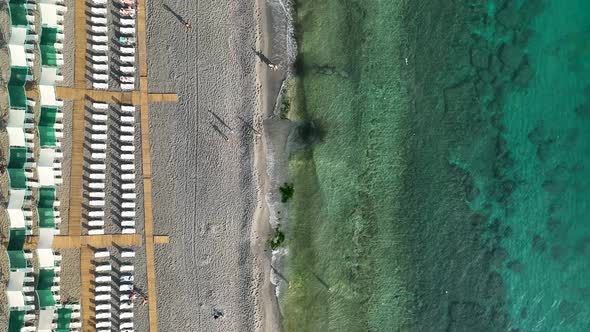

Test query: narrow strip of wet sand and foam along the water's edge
[251,0,292,332]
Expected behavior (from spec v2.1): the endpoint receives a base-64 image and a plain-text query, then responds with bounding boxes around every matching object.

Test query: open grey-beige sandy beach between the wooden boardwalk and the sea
[145,0,290,331]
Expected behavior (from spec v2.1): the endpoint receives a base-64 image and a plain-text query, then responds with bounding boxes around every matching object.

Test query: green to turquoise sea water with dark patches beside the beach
[281,0,590,331]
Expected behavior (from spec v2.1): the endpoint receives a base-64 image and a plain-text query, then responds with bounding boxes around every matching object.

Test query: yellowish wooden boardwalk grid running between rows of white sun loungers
[59,0,178,332]
